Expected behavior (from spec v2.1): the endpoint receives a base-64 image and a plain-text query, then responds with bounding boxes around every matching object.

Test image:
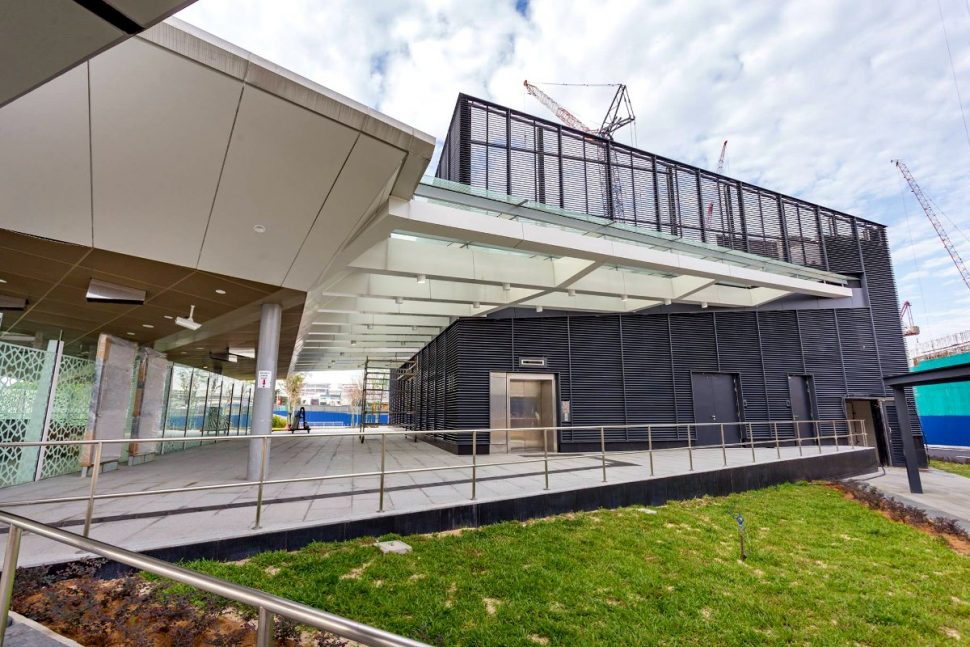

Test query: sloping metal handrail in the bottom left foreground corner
[0,511,428,647]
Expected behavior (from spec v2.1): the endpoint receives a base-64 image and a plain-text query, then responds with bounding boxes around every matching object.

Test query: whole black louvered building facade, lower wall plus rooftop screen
[391,95,925,464]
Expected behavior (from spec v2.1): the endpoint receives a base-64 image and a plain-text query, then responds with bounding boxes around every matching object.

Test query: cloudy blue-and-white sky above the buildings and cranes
[179,0,970,350]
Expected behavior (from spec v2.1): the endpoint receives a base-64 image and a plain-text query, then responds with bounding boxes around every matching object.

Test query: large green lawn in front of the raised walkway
[168,484,970,646]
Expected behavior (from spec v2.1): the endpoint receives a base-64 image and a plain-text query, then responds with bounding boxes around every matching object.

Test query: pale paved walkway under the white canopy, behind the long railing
[0,431,864,566]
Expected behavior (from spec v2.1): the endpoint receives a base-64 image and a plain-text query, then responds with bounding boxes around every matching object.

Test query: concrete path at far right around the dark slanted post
[850,467,970,532]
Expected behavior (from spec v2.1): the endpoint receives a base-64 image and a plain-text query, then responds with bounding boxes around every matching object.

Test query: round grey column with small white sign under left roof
[246,303,283,481]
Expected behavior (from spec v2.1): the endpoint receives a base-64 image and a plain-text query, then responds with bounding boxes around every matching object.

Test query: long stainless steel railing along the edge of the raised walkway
[0,419,868,537]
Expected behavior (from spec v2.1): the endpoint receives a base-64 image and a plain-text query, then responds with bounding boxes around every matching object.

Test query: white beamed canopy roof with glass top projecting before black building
[291,180,852,370]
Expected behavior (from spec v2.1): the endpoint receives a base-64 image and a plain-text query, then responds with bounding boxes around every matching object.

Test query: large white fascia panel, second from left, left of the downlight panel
[89,38,242,274]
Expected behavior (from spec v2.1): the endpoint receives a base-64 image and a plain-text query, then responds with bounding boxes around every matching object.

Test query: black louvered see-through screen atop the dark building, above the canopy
[436,95,878,272]
